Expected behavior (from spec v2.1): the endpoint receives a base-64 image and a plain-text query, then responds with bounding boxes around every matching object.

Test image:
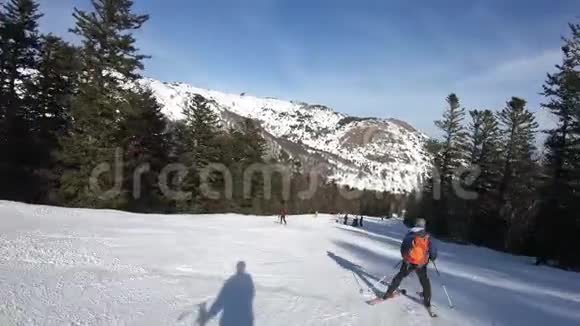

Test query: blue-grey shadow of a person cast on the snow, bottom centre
[197,261,255,326]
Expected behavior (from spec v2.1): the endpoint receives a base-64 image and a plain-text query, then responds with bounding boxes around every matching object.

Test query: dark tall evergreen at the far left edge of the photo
[0,0,42,201]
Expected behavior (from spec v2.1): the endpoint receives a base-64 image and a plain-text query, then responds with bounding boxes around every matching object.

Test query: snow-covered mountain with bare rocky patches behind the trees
[141,79,430,193]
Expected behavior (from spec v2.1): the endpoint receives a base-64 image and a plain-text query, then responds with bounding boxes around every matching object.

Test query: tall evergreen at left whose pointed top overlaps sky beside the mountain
[61,0,148,208]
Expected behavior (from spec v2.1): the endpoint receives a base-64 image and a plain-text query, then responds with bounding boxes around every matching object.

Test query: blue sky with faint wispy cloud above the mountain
[40,0,580,135]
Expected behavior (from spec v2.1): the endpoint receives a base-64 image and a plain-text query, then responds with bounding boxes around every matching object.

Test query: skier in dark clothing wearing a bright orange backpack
[383,218,437,310]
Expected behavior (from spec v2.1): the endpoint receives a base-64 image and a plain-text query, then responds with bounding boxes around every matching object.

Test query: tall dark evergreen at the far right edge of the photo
[536,24,580,266]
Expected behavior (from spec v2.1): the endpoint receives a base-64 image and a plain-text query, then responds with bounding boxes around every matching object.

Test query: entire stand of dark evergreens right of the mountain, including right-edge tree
[410,24,580,267]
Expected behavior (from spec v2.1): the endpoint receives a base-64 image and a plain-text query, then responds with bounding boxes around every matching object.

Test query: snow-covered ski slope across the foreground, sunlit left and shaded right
[0,202,580,326]
